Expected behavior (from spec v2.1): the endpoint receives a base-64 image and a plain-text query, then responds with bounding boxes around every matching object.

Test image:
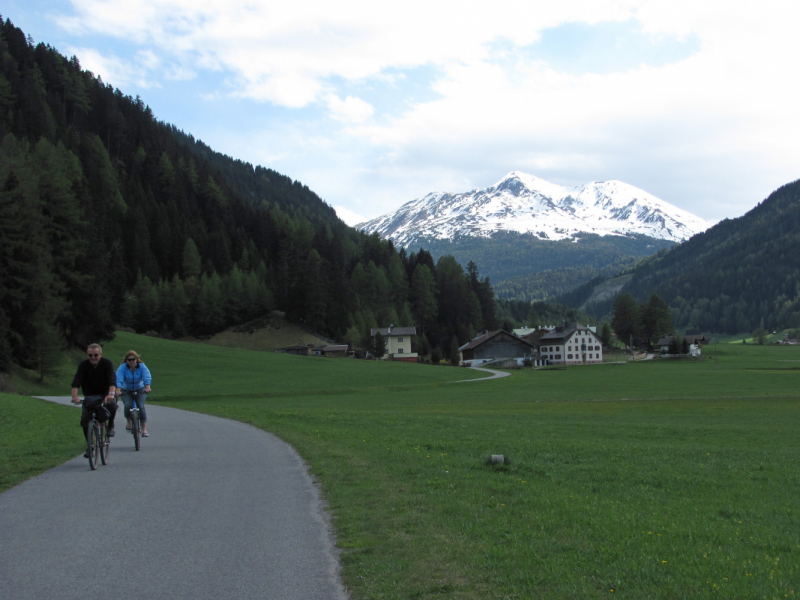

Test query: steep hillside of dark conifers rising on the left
[0,20,495,375]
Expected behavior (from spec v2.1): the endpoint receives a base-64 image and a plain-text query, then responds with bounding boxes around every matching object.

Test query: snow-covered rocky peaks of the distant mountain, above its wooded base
[356,171,711,247]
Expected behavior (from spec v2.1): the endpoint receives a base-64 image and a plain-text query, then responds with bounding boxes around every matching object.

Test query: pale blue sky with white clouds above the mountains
[2,0,800,224]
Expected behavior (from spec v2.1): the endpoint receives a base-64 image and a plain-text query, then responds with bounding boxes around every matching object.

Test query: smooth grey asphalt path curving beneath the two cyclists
[0,398,347,600]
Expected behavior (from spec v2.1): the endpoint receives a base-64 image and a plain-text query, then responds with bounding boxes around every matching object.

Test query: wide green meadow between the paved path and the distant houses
[0,334,800,599]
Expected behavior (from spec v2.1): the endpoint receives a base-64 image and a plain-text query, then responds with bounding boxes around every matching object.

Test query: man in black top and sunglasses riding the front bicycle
[72,344,117,454]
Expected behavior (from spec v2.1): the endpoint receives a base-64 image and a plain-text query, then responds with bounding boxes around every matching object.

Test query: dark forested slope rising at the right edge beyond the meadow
[584,181,800,334]
